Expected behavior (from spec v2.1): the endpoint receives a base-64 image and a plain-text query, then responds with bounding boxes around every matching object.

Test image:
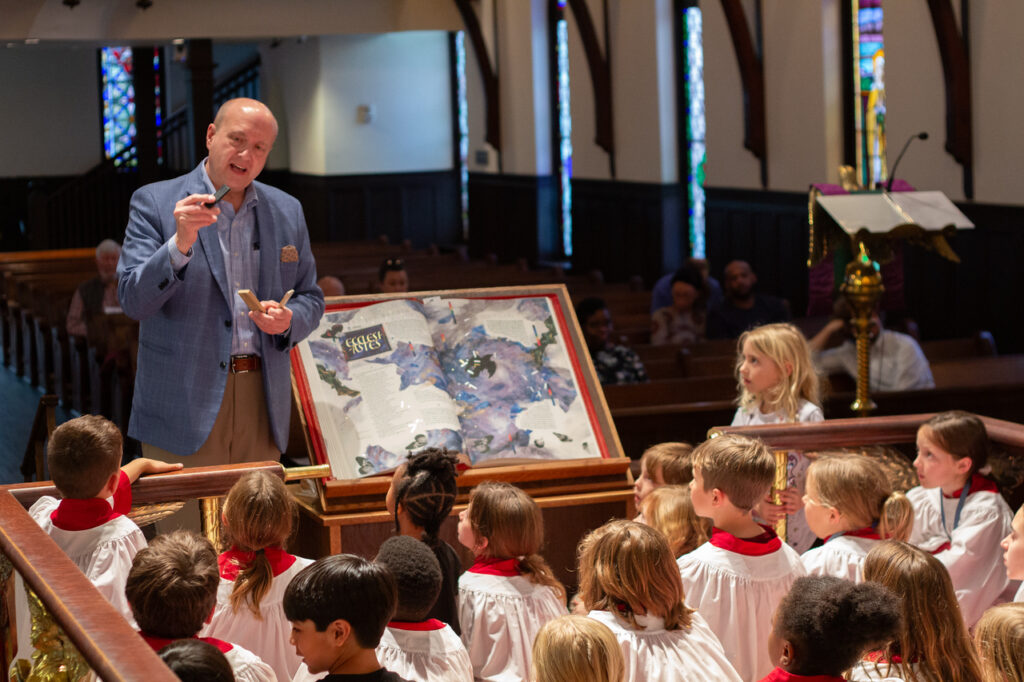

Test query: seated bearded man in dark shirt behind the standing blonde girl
[708,260,790,339]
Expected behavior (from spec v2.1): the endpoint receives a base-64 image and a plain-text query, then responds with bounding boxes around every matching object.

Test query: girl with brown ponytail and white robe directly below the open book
[459,482,566,680]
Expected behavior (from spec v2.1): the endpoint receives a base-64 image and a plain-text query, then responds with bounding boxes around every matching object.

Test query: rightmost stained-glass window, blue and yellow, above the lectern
[850,0,888,187]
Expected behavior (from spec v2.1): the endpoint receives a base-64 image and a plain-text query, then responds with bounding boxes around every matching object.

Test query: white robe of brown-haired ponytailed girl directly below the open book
[459,571,566,682]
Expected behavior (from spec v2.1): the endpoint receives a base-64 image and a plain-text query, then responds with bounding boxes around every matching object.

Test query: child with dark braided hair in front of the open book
[384,447,462,635]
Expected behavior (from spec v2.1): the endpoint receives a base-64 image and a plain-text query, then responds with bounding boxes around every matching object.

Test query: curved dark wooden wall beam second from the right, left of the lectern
[722,0,768,187]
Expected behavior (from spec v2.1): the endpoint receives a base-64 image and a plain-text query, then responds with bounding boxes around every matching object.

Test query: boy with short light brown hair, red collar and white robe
[677,434,805,682]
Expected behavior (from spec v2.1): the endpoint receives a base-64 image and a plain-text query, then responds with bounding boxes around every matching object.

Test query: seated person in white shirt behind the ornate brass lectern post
[808,299,935,393]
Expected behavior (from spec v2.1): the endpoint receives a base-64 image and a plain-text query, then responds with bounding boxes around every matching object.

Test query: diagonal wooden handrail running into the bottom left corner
[0,491,177,682]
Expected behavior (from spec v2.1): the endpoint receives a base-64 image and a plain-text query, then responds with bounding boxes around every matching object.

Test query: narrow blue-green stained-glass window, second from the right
[683,7,708,258]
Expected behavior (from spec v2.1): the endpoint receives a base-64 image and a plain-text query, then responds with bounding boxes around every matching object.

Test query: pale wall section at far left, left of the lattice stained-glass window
[0,45,103,177]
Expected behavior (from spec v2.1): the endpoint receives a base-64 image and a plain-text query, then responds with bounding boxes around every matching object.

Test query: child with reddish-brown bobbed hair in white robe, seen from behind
[579,520,740,682]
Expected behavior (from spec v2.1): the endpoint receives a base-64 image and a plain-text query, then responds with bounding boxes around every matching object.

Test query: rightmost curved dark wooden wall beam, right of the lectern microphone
[928,0,974,199]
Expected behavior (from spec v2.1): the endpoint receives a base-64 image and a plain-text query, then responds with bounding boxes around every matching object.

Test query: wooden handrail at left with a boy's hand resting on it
[0,462,285,509]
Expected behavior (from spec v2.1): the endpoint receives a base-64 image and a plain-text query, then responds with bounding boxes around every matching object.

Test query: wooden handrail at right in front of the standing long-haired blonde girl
[710,413,1024,452]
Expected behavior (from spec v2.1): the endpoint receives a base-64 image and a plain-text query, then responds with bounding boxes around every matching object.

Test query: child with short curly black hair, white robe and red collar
[375,536,473,682]
